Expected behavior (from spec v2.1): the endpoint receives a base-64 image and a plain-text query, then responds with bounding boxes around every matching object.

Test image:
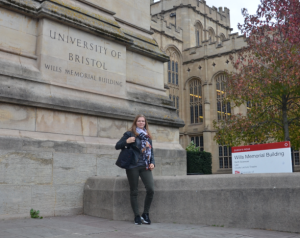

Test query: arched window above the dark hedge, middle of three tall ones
[189,79,203,124]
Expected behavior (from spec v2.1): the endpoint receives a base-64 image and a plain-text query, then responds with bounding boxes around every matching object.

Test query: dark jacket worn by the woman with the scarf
[115,131,155,166]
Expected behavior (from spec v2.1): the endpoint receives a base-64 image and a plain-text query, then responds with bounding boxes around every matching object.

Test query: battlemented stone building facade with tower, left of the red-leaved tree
[151,0,300,173]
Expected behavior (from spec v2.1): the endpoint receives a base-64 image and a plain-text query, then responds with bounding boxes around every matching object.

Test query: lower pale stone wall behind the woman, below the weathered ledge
[0,103,186,219]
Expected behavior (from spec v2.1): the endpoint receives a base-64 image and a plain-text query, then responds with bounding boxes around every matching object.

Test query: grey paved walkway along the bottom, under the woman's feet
[0,216,300,238]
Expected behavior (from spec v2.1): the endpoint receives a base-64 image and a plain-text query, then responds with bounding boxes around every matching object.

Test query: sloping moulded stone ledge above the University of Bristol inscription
[0,0,169,62]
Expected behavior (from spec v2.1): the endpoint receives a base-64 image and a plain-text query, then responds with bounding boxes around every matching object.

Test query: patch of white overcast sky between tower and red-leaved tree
[155,0,260,33]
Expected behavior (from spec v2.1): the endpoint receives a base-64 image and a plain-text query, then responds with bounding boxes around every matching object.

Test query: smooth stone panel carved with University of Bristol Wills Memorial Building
[37,20,126,96]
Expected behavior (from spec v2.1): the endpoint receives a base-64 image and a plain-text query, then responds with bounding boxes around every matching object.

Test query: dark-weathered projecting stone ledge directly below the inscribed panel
[0,76,184,127]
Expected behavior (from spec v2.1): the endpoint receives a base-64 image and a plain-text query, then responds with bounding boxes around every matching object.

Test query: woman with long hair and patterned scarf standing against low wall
[116,115,155,225]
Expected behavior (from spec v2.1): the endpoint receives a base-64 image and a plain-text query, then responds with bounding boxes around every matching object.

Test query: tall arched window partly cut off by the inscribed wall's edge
[166,48,180,116]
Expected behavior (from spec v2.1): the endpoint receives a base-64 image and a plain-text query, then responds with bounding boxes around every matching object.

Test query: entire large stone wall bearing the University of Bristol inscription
[0,0,186,219]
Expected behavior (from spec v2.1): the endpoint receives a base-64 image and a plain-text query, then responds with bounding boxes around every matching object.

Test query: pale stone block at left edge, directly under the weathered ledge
[0,103,36,131]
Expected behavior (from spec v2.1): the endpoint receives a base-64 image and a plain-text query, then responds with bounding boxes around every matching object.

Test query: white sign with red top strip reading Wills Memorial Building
[232,141,293,174]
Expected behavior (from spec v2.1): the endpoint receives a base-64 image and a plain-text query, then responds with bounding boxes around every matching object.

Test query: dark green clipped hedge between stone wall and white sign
[187,150,212,174]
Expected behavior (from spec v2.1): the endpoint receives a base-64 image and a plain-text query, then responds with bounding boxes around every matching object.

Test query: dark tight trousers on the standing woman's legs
[126,166,154,216]
